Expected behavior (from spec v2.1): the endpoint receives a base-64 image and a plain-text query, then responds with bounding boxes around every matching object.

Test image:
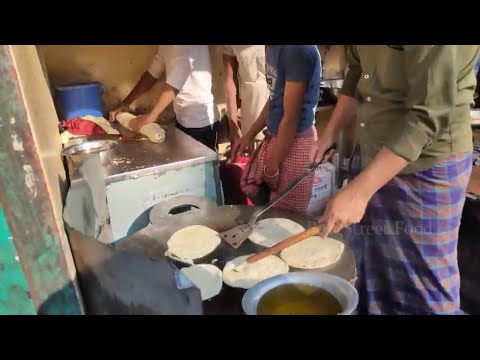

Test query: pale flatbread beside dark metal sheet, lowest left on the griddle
[180,264,223,301]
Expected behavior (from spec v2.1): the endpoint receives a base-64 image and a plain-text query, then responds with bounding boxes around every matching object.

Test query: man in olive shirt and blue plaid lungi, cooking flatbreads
[311,45,479,314]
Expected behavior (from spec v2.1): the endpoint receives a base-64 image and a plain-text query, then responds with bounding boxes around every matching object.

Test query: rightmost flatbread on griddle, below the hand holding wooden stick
[280,236,345,269]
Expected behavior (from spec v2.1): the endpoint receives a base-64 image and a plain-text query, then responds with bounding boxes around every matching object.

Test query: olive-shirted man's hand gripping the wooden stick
[318,183,370,238]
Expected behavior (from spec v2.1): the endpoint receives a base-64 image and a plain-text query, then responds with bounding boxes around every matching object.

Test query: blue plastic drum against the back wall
[56,82,103,120]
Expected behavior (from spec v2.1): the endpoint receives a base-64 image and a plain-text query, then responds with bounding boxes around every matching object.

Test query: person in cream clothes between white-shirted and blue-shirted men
[223,45,270,152]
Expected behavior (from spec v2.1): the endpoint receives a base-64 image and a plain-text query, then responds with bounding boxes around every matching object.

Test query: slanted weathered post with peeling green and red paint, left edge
[0,45,82,314]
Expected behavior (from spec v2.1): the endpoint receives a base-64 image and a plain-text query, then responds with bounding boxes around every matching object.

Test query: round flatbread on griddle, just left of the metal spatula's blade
[167,225,221,260]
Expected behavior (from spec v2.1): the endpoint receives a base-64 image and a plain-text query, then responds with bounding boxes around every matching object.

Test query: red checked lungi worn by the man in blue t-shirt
[240,126,317,212]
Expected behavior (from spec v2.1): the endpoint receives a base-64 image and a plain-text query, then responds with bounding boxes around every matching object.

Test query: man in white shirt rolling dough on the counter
[110,45,219,150]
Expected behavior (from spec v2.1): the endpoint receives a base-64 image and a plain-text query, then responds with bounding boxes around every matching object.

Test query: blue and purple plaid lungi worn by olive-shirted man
[345,147,472,315]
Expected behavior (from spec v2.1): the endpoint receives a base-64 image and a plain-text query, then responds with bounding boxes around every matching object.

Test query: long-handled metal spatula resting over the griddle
[220,162,322,249]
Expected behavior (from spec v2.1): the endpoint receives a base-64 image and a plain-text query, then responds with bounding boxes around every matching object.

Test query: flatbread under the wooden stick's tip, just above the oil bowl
[223,255,289,289]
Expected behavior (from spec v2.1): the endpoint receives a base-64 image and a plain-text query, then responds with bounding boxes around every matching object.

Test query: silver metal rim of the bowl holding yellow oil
[242,271,358,315]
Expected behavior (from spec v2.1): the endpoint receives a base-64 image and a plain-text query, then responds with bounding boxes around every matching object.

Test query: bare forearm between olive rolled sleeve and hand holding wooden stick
[348,147,408,199]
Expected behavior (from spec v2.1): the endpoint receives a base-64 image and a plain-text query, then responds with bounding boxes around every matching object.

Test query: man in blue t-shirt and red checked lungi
[231,45,321,212]
